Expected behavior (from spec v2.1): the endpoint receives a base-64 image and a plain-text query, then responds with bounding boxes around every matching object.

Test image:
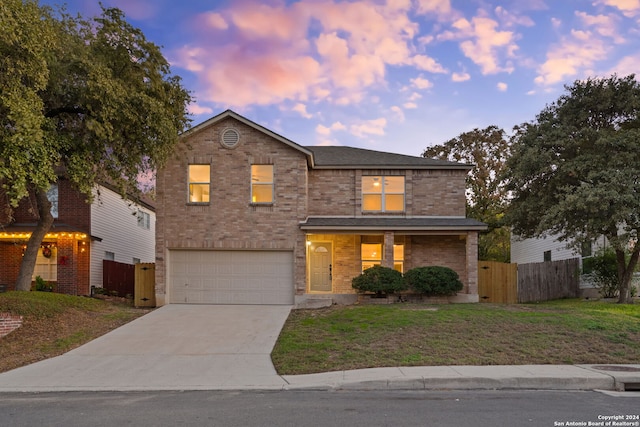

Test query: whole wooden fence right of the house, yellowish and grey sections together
[478,258,580,304]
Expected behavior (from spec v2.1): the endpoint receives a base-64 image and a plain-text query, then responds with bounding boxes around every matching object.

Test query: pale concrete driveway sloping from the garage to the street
[0,304,291,392]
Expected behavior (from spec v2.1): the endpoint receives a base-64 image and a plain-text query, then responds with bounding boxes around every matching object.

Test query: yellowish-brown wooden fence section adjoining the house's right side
[478,261,518,304]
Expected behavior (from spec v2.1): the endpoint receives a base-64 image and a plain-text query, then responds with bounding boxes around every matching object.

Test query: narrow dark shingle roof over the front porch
[300,217,487,231]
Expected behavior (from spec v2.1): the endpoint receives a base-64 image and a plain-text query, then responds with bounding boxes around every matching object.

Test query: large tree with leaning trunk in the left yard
[0,0,191,290]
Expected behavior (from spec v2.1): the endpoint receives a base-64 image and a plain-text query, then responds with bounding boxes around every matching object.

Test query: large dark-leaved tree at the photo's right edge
[507,75,640,303]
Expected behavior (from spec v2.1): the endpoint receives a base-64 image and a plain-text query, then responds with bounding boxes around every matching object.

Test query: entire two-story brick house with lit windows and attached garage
[156,110,485,305]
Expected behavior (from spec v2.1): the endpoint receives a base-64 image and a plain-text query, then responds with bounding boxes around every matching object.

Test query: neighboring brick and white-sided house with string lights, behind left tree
[0,178,155,295]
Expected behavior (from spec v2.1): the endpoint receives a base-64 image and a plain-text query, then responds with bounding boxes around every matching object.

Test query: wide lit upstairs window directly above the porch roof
[362,176,404,212]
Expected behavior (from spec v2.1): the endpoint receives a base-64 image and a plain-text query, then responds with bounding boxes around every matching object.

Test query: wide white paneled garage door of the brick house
[168,250,293,304]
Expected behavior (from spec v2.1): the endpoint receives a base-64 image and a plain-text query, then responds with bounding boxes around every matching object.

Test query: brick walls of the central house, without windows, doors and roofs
[156,110,477,305]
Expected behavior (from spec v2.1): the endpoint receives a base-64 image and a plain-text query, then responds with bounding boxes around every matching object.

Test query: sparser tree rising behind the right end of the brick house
[422,126,511,262]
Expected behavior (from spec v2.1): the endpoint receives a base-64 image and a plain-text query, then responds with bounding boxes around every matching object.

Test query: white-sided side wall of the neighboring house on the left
[89,186,156,287]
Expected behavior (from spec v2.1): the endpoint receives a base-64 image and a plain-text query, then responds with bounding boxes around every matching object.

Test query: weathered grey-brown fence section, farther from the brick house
[518,258,580,302]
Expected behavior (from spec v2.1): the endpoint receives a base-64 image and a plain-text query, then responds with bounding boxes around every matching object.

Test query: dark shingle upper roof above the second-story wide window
[304,146,472,169]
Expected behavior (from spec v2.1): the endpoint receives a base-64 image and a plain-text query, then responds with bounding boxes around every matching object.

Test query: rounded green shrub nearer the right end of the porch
[404,266,463,296]
